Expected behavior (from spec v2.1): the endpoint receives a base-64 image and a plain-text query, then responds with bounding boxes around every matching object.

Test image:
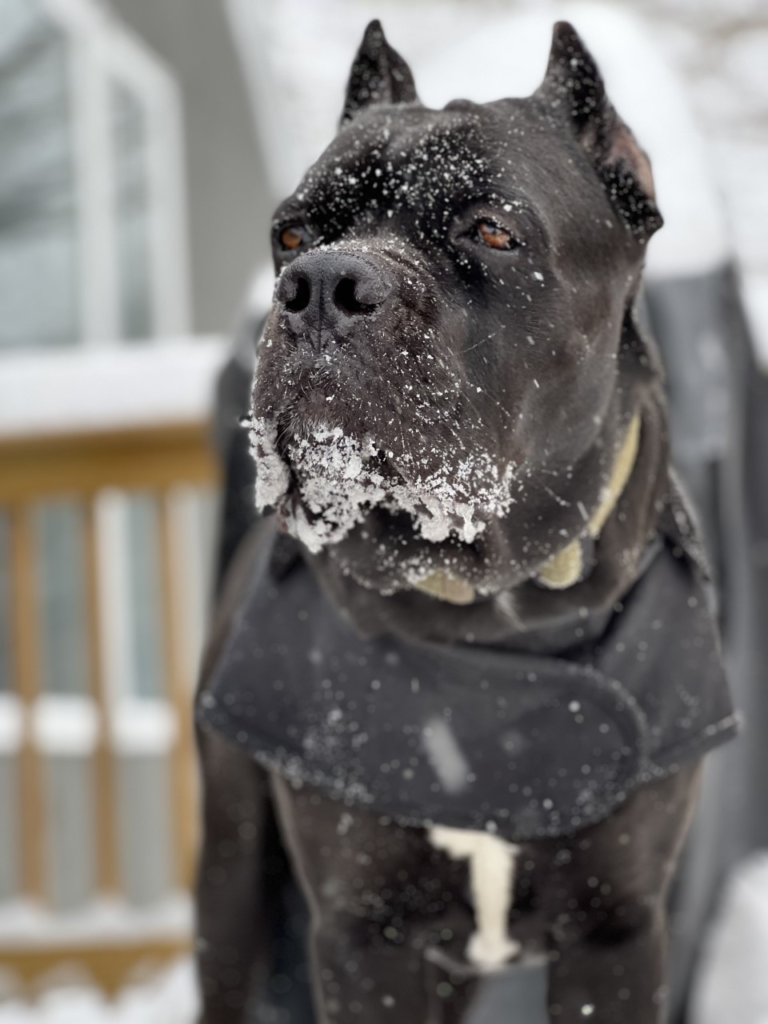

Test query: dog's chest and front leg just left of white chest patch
[272,777,472,1024]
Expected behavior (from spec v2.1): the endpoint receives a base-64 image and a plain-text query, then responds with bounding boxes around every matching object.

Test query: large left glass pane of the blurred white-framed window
[0,0,81,351]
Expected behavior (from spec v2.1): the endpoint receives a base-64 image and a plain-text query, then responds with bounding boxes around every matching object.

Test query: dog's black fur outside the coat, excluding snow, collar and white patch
[199,23,698,1024]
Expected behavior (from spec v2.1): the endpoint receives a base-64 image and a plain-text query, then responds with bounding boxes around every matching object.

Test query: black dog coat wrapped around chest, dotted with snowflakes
[198,483,736,841]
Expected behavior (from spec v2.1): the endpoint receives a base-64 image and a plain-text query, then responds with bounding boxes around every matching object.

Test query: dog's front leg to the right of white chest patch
[542,763,700,1024]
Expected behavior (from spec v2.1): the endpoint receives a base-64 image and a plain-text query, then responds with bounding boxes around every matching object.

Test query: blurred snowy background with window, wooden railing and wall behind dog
[0,0,768,1024]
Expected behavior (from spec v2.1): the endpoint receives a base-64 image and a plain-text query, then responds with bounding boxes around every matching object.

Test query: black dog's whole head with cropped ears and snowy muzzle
[252,23,662,593]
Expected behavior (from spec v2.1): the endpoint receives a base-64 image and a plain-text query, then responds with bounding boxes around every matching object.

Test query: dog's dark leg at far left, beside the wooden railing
[197,732,269,1024]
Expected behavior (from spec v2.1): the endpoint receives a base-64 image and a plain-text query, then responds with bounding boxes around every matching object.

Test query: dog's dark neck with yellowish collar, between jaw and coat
[308,375,669,651]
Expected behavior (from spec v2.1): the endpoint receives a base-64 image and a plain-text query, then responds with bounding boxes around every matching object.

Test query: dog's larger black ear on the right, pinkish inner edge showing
[537,22,664,241]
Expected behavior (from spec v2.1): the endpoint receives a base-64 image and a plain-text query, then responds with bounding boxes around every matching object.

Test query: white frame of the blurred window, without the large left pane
[41,0,189,347]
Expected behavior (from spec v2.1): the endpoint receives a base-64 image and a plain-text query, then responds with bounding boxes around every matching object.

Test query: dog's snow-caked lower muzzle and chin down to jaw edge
[252,393,525,595]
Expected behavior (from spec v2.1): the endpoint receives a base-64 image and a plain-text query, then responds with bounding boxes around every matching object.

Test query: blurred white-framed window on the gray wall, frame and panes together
[0,0,188,353]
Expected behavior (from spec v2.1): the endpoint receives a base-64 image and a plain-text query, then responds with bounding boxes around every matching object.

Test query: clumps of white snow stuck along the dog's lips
[251,417,514,554]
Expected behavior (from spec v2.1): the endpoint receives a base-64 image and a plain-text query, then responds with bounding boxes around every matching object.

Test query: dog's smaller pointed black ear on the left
[341,22,418,125]
